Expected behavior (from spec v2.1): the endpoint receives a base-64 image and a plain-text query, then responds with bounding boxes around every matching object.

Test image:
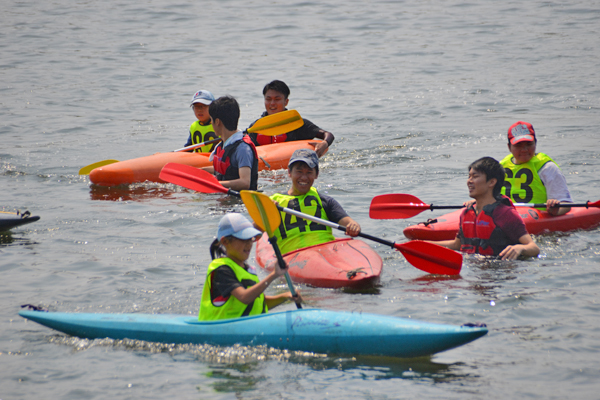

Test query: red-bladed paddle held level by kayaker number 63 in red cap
[369,194,600,219]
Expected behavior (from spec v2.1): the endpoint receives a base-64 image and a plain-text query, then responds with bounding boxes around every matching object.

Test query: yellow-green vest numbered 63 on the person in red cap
[500,153,554,203]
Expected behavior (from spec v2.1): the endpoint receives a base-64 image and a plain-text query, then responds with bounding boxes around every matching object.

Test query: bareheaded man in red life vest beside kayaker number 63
[426,157,540,260]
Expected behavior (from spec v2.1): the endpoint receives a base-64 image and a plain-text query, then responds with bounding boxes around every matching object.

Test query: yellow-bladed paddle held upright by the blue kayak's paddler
[240,190,302,309]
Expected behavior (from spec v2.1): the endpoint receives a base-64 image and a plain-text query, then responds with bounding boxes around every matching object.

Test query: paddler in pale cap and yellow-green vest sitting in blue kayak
[198,213,302,321]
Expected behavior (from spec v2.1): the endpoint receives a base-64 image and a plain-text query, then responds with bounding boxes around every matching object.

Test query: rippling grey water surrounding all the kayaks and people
[0,0,600,399]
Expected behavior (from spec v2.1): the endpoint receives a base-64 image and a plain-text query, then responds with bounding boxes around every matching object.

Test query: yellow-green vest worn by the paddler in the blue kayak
[198,257,268,321]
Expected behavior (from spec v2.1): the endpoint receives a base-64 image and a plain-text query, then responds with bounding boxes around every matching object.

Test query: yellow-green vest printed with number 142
[271,188,335,254]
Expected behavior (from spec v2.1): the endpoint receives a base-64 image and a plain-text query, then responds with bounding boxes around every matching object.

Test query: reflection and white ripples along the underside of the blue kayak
[47,334,477,392]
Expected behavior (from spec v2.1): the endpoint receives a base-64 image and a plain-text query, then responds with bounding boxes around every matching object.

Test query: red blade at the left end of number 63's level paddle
[369,194,430,219]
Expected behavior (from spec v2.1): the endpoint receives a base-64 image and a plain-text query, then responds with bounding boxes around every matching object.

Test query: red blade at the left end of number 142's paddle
[158,163,227,193]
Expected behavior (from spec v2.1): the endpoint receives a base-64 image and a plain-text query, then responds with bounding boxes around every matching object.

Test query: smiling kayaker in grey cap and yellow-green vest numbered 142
[271,149,360,254]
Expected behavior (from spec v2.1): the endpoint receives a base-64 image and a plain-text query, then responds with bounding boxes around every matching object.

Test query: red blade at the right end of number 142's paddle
[394,240,462,275]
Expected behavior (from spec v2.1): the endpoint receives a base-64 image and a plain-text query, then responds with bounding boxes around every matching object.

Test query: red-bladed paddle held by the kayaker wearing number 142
[160,163,462,275]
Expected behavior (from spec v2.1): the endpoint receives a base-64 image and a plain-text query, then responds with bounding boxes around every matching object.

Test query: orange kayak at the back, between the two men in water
[90,139,320,186]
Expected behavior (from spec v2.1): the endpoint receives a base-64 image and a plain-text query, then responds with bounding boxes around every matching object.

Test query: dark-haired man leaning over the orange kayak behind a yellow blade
[248,80,335,157]
